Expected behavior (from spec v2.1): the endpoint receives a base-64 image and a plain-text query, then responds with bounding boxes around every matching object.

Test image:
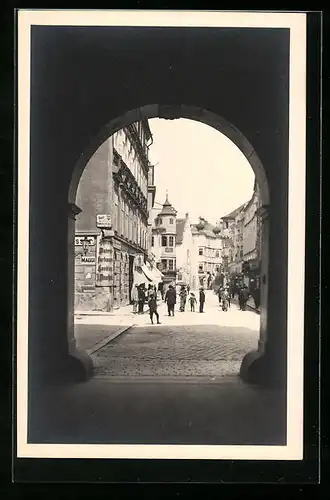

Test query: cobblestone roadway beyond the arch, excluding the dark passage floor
[93,292,259,377]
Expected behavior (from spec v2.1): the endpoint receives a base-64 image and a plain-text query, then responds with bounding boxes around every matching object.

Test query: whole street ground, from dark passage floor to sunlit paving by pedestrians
[30,292,286,445]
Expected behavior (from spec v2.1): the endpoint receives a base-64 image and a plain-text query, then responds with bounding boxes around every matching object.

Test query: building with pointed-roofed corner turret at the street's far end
[151,195,177,284]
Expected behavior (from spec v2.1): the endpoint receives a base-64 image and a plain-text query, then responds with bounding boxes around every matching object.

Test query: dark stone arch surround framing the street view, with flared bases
[68,104,270,382]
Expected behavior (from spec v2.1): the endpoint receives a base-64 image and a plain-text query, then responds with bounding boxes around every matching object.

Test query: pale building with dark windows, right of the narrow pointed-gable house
[191,217,223,287]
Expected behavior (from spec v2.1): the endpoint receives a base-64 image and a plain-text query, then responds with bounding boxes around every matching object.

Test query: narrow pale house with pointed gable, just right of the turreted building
[176,213,199,290]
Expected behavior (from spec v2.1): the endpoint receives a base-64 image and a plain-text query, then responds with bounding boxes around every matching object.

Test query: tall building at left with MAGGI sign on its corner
[75,120,155,311]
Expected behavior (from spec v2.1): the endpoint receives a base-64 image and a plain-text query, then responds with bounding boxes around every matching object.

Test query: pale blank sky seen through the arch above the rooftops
[149,118,254,224]
